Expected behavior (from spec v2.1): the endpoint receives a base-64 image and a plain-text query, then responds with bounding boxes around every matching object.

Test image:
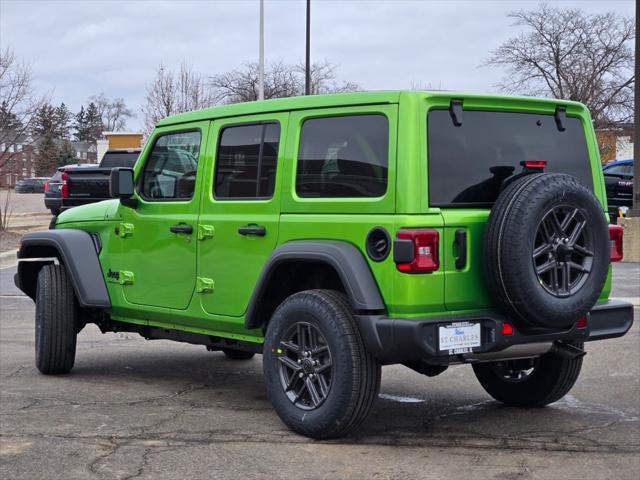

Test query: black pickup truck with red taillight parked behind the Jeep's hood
[45,148,140,215]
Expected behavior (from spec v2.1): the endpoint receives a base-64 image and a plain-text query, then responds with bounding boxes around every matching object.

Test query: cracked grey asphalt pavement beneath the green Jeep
[0,264,640,480]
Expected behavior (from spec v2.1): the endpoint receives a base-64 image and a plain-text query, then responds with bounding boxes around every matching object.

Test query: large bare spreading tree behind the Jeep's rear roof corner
[485,4,635,126]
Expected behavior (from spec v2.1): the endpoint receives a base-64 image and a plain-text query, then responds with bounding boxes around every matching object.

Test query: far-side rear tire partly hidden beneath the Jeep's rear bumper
[473,344,582,408]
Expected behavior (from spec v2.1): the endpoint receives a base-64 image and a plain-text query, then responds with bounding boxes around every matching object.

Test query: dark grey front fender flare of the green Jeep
[14,229,111,308]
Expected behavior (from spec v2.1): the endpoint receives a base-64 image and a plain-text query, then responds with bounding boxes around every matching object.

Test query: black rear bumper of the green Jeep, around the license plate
[355,300,633,365]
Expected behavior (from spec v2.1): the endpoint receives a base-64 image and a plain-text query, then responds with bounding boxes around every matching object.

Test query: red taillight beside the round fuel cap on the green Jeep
[393,228,440,273]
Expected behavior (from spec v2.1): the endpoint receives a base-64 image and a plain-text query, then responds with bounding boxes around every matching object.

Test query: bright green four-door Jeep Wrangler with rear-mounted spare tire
[15,92,633,438]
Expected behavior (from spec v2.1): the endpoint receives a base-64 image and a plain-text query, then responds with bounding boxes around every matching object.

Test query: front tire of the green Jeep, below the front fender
[36,265,78,375]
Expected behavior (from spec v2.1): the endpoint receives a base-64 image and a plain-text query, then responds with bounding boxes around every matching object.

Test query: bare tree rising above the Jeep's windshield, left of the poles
[142,63,215,131]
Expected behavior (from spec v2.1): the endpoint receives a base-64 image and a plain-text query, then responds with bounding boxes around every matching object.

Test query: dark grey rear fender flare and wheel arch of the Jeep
[245,240,385,329]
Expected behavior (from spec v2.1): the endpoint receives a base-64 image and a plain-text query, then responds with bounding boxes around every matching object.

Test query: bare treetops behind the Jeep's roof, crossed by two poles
[210,61,360,103]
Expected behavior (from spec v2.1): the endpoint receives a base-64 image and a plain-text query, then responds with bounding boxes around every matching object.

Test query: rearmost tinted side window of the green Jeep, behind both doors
[296,115,389,198]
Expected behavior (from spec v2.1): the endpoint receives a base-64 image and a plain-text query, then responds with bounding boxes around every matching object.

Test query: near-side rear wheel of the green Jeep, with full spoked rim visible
[263,290,381,439]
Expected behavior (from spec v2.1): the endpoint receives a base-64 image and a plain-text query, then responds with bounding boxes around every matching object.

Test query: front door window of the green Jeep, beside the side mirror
[141,132,200,200]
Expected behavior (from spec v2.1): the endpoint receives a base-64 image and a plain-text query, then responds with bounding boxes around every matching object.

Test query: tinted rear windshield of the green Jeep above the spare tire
[427,110,593,206]
